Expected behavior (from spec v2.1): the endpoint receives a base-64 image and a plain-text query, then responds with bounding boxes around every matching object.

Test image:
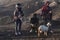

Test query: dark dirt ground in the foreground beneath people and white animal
[0,21,60,40]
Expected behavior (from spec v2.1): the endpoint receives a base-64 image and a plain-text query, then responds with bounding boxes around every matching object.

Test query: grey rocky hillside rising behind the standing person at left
[0,0,42,22]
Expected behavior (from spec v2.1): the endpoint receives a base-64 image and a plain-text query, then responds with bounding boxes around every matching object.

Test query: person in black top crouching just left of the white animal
[30,14,39,32]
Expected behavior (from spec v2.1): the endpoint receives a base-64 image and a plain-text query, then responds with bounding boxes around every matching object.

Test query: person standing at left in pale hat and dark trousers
[14,3,24,35]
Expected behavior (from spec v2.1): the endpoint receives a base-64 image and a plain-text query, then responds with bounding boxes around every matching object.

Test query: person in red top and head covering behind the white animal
[42,1,52,23]
